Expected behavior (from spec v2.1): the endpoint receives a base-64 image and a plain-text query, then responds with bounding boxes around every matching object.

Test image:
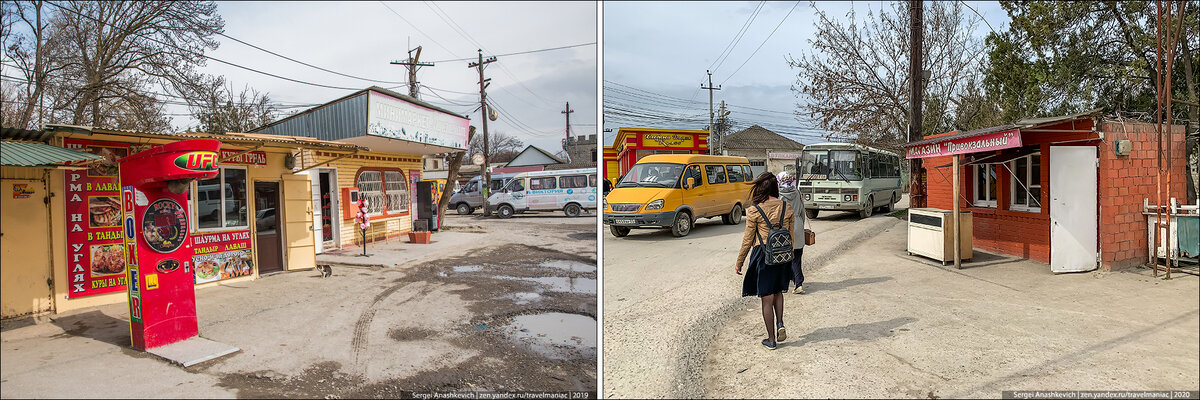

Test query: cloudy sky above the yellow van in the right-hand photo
[604,1,1008,144]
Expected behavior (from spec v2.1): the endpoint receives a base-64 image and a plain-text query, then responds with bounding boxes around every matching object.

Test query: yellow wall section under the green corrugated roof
[0,167,54,318]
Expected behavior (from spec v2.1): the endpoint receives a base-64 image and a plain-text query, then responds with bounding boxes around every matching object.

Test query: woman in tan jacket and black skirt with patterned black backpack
[736,172,796,350]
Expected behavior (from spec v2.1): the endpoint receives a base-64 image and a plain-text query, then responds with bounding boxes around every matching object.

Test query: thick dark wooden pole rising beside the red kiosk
[908,0,921,205]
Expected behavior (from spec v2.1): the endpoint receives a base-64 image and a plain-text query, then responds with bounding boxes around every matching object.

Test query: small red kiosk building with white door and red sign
[906,111,1187,270]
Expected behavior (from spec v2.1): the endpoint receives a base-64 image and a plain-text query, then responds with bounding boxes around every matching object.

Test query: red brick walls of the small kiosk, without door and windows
[924,119,1186,270]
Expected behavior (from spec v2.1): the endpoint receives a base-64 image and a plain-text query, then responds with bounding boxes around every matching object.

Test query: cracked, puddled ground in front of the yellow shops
[0,214,598,398]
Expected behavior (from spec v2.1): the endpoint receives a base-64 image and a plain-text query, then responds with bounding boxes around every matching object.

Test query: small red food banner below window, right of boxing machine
[192,229,254,285]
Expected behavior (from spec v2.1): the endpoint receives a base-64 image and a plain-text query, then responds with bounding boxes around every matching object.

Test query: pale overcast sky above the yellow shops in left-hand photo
[169,1,598,153]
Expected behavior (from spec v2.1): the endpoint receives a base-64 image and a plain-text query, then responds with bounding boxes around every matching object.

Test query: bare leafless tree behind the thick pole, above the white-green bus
[787,1,989,149]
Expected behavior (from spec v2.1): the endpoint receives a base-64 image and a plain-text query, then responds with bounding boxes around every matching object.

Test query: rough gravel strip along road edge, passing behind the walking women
[670,215,901,399]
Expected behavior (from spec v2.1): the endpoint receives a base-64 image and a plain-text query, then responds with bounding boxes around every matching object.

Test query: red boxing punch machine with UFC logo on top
[119,139,221,351]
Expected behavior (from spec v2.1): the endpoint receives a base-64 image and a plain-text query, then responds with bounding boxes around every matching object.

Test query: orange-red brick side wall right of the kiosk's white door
[1098,121,1187,270]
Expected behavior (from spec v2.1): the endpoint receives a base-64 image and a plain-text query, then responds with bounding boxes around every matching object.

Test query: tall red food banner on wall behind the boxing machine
[64,139,148,298]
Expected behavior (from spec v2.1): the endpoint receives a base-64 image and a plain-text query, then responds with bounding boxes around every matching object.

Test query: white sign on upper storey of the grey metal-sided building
[367,91,469,150]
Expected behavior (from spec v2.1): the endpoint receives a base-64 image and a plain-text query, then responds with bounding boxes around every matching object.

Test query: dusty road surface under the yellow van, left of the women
[604,201,907,398]
